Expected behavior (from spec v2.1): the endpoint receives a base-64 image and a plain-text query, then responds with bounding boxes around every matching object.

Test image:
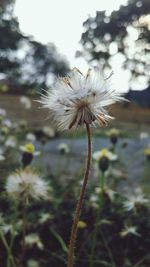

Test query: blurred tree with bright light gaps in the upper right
[77,0,150,89]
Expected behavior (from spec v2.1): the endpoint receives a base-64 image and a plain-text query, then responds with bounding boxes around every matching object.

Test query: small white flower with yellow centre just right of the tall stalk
[92,148,118,161]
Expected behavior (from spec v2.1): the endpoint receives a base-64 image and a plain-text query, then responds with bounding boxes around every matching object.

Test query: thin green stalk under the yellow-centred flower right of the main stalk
[89,173,105,267]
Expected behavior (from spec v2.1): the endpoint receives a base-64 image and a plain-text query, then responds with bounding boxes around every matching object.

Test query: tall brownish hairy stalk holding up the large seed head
[67,124,92,267]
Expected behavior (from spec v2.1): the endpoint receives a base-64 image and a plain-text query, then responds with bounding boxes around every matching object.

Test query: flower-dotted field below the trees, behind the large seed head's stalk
[0,95,150,267]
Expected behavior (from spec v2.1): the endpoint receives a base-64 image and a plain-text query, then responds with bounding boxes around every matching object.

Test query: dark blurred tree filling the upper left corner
[0,0,69,92]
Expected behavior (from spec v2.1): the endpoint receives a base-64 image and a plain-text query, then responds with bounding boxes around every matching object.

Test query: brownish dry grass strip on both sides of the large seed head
[0,94,150,129]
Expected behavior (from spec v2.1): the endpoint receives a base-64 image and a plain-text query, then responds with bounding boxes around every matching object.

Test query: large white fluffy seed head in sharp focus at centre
[40,68,123,130]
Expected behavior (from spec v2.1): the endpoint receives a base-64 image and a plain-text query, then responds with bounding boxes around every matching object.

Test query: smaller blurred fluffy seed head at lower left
[6,169,48,199]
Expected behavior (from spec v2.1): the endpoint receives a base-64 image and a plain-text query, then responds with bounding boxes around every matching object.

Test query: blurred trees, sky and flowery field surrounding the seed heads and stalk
[0,0,150,267]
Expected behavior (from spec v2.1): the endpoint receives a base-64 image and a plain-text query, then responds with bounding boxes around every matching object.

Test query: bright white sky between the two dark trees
[15,0,129,90]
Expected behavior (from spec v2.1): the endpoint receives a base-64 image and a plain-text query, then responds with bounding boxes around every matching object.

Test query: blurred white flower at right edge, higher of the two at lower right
[123,194,149,211]
